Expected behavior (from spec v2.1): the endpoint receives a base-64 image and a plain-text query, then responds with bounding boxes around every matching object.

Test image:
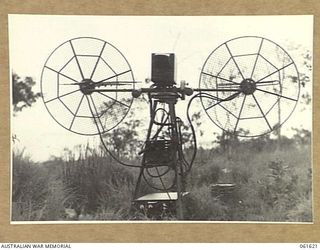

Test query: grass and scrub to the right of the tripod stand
[186,137,312,221]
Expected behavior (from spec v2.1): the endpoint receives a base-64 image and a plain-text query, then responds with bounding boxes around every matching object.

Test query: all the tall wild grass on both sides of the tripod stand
[12,138,312,222]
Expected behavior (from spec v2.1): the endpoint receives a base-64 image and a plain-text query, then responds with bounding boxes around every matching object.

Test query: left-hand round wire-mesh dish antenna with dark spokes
[41,37,134,135]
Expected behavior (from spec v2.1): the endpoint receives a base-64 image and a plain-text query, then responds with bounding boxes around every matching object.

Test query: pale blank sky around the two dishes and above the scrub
[9,15,313,161]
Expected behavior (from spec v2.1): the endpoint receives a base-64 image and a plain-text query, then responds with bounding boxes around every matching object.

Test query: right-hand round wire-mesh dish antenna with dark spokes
[199,36,300,137]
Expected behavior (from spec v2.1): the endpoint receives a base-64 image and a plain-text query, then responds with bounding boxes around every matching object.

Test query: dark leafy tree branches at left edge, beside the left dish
[12,73,41,112]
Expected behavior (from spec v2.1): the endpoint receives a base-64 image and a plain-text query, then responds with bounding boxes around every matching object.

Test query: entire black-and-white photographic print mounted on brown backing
[8,14,314,224]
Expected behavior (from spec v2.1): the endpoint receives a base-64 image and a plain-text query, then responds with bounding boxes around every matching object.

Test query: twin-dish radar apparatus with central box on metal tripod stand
[41,36,300,219]
